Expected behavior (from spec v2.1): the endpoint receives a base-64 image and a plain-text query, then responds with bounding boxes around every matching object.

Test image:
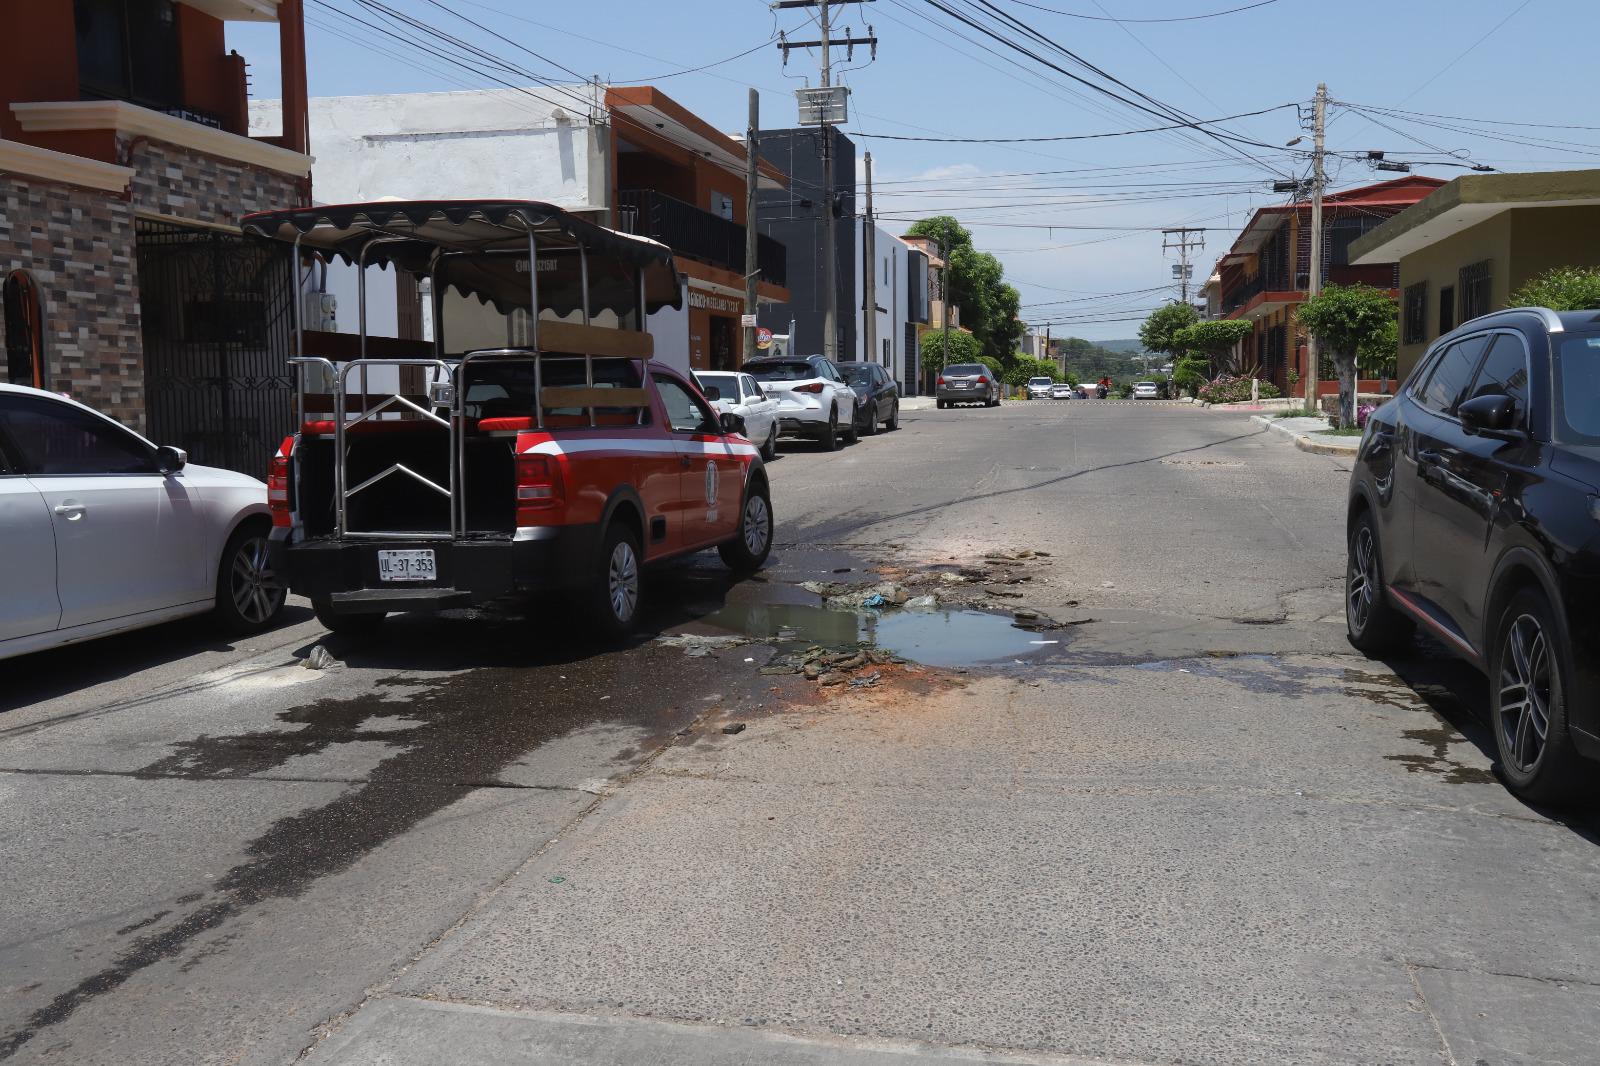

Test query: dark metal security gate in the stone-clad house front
[136,219,294,477]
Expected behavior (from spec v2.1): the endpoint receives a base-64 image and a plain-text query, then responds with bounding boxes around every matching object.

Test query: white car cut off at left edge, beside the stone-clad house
[0,384,283,659]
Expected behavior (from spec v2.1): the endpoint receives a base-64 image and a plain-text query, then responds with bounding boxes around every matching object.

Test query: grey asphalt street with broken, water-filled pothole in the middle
[0,402,1600,1066]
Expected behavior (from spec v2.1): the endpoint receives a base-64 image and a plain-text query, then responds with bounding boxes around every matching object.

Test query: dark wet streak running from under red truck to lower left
[0,619,752,1060]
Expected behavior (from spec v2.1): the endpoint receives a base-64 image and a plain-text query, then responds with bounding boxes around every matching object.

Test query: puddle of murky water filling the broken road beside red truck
[701,603,1064,666]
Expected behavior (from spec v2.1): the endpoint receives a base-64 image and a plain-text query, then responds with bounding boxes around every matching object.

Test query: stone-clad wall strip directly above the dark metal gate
[117,136,302,226]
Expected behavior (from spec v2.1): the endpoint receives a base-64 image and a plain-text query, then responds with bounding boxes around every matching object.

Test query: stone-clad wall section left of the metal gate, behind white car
[0,174,144,427]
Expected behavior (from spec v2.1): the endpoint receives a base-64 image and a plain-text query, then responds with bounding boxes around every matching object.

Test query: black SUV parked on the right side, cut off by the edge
[1346,307,1600,802]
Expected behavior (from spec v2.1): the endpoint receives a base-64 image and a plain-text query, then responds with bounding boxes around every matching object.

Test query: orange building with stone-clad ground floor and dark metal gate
[0,0,312,472]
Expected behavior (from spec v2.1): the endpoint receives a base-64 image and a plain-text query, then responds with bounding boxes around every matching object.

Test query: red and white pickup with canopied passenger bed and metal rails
[243,200,773,635]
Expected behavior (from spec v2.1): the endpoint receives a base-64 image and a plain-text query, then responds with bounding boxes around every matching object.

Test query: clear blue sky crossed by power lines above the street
[229,0,1600,338]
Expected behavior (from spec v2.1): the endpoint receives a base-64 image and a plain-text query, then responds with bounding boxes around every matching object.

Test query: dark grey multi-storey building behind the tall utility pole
[757,126,861,359]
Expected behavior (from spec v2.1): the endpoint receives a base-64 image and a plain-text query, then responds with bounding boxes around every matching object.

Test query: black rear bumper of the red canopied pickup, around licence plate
[269,525,600,613]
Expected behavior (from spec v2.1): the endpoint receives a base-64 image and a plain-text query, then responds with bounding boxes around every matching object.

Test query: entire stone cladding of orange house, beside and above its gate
[0,138,306,432]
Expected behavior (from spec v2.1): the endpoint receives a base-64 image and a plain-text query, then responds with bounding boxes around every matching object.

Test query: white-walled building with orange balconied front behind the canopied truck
[250,85,787,371]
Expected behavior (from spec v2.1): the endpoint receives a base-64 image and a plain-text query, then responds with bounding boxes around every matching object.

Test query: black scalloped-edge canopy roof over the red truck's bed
[240,200,682,315]
